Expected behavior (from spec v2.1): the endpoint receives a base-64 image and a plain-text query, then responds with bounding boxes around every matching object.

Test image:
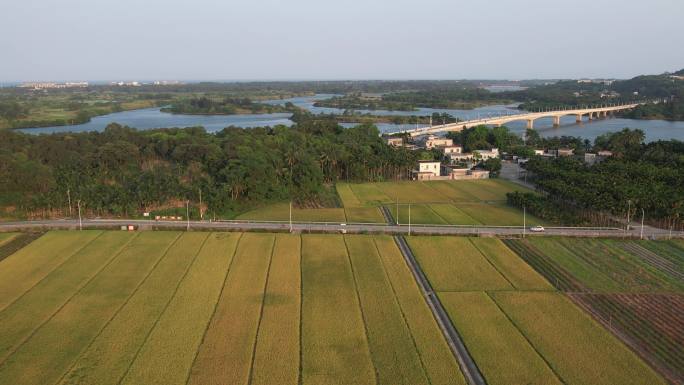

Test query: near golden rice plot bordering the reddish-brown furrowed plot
[492,292,665,384]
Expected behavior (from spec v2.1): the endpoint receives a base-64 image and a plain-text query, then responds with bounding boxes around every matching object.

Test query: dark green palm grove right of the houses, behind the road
[509,129,684,229]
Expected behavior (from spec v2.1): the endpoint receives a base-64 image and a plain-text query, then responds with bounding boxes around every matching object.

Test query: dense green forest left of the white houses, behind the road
[0,120,419,217]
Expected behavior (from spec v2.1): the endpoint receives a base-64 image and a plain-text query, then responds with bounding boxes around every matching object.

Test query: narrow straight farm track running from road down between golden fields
[394,236,486,385]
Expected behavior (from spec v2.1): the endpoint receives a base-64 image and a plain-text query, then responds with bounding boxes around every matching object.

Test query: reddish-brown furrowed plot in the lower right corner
[568,293,684,384]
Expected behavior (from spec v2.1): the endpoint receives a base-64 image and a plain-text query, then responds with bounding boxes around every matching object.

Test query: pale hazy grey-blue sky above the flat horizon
[0,0,684,82]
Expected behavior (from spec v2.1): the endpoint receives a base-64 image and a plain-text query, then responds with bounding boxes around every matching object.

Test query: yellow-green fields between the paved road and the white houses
[237,179,548,226]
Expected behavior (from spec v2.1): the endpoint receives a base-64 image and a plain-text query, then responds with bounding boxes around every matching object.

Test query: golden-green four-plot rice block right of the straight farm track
[408,236,664,384]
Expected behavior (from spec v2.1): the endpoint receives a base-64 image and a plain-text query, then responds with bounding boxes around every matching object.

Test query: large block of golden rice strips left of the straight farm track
[0,231,465,384]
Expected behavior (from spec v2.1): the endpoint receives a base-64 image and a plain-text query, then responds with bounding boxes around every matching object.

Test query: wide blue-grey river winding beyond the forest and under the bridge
[21,94,684,141]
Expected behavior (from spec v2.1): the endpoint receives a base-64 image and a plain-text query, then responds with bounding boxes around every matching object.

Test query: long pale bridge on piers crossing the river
[390,103,642,136]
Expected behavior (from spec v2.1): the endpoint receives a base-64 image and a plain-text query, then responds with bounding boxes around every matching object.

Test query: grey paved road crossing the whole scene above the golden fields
[0,219,684,238]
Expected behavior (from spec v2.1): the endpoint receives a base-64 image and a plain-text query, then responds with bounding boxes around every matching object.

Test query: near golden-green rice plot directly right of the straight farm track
[439,292,561,385]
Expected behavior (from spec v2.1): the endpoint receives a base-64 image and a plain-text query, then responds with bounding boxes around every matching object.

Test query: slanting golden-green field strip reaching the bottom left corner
[0,232,179,384]
